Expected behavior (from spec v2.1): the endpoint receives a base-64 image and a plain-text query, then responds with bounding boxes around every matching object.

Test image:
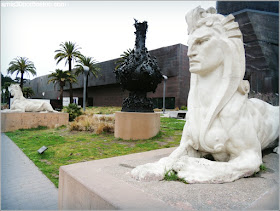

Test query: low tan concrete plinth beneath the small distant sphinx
[1,112,69,132]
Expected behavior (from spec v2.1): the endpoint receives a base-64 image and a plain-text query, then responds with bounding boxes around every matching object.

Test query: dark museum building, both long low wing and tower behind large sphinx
[25,1,279,109]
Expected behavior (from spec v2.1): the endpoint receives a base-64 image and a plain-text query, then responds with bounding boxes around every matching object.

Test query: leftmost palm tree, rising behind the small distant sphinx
[8,57,36,89]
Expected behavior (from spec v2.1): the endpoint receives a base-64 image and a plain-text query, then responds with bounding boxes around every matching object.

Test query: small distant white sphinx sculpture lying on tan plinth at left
[1,84,57,113]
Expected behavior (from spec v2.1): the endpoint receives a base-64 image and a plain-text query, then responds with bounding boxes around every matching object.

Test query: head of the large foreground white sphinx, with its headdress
[186,7,245,78]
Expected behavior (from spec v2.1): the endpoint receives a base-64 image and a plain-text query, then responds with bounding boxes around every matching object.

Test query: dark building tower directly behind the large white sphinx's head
[216,1,279,93]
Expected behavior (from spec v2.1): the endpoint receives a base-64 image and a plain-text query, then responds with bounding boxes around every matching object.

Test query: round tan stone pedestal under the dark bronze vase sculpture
[115,112,160,140]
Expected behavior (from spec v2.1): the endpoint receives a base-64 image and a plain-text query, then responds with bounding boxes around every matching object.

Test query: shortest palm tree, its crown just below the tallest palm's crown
[48,69,77,106]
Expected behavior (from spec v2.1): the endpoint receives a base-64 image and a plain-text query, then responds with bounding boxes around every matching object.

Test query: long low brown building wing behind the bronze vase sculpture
[25,44,190,108]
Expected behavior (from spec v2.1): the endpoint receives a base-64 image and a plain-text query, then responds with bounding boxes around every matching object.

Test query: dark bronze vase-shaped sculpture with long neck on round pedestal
[114,20,163,112]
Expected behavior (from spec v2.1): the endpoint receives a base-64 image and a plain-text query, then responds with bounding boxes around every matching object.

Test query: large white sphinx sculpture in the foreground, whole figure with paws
[131,7,279,183]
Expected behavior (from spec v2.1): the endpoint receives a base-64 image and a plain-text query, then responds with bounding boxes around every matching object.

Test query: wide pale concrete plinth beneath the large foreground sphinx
[58,148,279,210]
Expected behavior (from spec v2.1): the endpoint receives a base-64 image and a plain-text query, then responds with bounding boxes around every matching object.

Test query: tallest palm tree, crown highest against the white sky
[54,41,82,103]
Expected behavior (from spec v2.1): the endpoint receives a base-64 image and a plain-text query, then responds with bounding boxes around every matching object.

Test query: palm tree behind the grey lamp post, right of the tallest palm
[75,55,100,106]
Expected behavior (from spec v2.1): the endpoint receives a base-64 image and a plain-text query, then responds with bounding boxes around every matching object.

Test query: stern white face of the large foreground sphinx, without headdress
[188,26,225,75]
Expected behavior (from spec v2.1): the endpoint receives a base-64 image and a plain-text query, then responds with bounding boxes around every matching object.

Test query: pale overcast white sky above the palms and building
[1,1,216,79]
